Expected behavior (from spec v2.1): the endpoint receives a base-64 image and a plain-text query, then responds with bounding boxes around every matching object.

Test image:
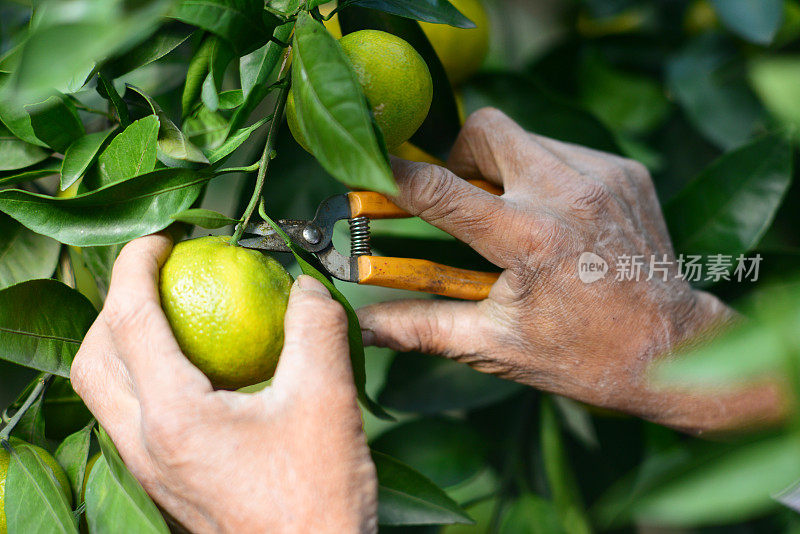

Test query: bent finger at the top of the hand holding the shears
[447,108,565,192]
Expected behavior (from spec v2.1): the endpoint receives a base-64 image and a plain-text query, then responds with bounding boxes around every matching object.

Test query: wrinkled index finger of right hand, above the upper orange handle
[392,158,511,267]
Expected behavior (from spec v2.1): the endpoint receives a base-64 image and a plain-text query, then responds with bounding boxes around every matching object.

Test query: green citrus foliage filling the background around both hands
[0,0,800,534]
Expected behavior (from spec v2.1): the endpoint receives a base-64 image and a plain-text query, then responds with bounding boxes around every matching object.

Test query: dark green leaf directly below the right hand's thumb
[378,353,523,414]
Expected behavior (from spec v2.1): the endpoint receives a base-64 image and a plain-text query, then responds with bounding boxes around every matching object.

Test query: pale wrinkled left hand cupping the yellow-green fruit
[71,235,377,533]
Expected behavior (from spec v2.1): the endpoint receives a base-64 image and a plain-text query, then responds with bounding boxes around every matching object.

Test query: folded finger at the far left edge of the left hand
[70,319,140,450]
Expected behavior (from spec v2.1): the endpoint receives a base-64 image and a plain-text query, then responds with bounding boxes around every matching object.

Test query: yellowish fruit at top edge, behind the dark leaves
[420,0,489,86]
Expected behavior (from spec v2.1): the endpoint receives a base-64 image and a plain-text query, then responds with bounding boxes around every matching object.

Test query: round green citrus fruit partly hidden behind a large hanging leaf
[286,30,433,150]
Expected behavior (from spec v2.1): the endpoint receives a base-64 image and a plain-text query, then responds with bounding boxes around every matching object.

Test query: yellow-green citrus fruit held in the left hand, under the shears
[159,237,292,389]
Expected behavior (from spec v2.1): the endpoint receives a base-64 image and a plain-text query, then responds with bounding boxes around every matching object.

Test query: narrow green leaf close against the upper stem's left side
[228,22,294,135]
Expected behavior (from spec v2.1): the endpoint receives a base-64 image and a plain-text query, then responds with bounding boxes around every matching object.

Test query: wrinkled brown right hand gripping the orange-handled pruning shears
[359,109,778,432]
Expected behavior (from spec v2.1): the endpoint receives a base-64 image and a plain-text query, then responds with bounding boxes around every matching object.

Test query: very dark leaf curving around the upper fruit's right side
[339,6,461,160]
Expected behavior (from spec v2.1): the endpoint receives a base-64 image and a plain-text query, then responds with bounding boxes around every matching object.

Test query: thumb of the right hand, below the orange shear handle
[358,300,487,359]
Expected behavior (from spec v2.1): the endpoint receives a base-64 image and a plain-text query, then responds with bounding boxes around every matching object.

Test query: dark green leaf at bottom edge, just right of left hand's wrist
[372,451,473,526]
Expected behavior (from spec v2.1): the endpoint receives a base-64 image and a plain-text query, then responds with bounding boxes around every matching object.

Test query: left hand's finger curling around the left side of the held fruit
[101,234,211,406]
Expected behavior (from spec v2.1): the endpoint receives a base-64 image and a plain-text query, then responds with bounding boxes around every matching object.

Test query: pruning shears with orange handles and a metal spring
[234,180,502,300]
